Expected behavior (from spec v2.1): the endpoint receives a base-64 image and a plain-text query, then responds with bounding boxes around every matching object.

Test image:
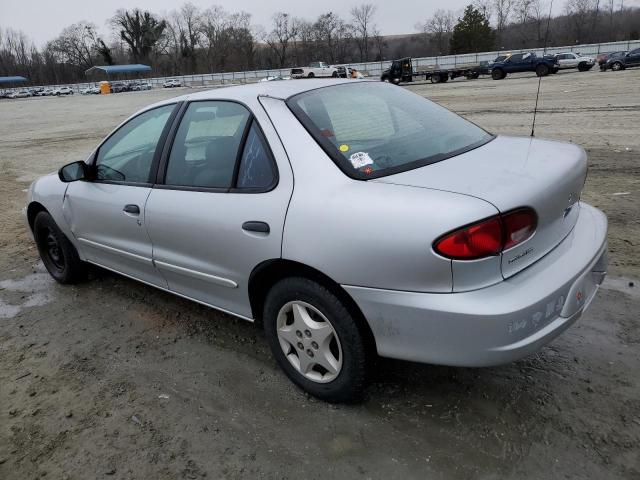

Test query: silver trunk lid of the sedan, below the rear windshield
[372,136,587,278]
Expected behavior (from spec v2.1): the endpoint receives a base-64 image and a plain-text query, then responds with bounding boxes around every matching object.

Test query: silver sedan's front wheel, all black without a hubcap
[33,212,87,284]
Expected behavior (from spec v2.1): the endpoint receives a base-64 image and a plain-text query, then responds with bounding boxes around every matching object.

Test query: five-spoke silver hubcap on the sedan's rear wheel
[276,300,342,383]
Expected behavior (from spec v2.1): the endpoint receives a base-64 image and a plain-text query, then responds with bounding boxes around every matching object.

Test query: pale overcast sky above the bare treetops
[0,0,532,46]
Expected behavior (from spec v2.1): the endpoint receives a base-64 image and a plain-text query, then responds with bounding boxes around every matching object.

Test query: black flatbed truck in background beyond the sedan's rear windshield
[380,57,489,85]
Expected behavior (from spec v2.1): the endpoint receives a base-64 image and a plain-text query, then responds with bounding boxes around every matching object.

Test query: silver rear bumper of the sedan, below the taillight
[344,203,607,367]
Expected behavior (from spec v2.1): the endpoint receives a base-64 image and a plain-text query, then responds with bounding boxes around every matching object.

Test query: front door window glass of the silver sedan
[96,105,175,183]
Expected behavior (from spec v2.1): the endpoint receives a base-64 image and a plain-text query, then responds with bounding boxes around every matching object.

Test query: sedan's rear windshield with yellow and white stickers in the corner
[287,82,493,179]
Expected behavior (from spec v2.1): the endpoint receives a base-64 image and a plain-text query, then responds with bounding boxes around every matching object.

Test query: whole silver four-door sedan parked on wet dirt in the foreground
[25,80,607,401]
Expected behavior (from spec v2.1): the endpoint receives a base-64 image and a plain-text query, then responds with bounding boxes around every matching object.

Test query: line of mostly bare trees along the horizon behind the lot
[0,0,640,84]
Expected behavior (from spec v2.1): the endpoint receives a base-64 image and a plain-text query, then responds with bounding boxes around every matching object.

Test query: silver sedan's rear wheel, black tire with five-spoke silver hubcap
[263,277,370,403]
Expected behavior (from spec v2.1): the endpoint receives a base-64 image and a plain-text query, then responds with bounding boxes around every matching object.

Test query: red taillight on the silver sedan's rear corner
[433,208,538,260]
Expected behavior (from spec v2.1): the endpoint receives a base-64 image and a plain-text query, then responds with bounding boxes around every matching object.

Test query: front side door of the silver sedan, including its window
[63,105,175,287]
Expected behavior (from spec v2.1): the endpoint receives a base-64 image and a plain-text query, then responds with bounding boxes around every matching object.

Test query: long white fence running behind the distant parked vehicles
[2,40,640,92]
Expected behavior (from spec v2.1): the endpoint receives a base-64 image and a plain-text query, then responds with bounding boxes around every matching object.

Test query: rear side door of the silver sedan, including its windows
[146,101,293,318]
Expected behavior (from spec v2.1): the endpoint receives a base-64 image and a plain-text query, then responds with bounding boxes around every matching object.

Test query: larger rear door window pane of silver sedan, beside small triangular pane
[165,101,250,188]
